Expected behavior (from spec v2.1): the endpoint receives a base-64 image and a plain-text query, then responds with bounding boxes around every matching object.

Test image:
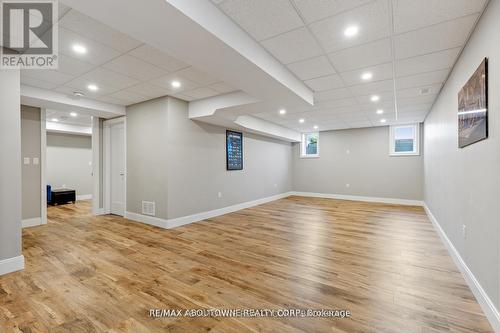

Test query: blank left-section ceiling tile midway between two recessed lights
[103,54,168,81]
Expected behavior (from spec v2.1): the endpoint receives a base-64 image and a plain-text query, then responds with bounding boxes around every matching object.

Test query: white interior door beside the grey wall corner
[109,122,126,216]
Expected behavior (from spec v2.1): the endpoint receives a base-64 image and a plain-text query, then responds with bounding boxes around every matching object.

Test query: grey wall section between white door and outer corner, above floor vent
[127,98,169,219]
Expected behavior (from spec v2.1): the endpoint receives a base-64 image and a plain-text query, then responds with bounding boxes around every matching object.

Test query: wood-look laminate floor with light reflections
[0,197,492,333]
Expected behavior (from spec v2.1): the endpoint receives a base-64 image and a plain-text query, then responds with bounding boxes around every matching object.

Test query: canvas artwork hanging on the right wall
[458,58,488,148]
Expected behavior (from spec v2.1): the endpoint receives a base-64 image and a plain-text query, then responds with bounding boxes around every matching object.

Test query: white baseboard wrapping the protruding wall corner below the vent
[125,192,291,229]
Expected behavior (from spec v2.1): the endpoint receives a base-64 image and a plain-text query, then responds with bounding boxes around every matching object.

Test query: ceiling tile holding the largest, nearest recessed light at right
[310,0,391,53]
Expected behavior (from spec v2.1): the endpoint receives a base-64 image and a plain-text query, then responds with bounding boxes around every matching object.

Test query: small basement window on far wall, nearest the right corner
[390,124,420,156]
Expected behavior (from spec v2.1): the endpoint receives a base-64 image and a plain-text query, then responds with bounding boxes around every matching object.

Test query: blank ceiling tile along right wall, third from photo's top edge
[396,47,461,77]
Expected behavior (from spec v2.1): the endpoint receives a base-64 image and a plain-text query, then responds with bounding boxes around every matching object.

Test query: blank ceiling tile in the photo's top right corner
[394,0,486,33]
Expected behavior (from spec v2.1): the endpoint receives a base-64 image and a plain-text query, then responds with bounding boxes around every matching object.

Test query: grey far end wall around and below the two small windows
[293,127,423,200]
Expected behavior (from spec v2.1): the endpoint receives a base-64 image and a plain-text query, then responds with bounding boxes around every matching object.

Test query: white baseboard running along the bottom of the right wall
[424,203,500,333]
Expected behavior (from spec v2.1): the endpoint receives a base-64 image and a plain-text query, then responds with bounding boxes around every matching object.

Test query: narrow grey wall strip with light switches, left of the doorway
[21,105,42,220]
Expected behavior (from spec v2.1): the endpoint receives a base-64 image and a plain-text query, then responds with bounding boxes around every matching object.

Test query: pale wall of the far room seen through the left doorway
[46,133,93,195]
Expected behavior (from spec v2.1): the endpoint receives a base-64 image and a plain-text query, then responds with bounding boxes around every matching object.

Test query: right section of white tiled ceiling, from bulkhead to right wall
[212,0,487,132]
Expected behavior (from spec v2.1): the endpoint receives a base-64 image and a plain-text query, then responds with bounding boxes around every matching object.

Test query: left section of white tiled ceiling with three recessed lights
[21,4,236,105]
